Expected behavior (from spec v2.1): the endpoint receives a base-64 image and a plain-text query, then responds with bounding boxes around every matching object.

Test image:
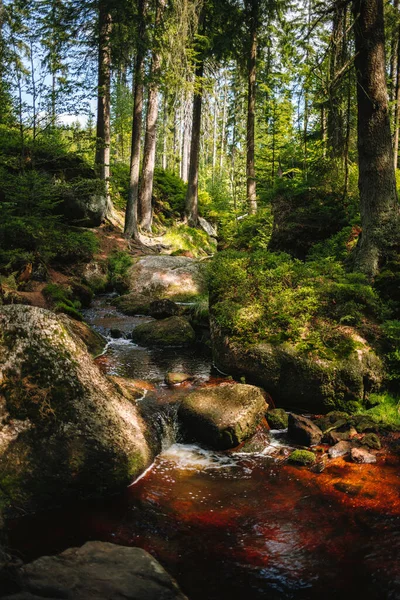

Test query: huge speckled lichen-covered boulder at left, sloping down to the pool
[0,306,155,510]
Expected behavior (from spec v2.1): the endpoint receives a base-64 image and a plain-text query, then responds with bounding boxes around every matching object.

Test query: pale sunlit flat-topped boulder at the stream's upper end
[118,255,206,314]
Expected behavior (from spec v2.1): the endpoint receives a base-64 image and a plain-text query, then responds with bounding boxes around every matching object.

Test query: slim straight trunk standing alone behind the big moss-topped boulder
[246,0,258,215]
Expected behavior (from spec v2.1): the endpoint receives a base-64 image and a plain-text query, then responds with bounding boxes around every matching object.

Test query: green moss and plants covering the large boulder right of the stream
[209,251,380,360]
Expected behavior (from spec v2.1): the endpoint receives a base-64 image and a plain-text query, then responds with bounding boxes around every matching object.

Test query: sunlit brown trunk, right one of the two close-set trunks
[139,0,164,231]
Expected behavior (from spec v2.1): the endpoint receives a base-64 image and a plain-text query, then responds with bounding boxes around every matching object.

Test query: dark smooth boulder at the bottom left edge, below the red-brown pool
[6,542,186,600]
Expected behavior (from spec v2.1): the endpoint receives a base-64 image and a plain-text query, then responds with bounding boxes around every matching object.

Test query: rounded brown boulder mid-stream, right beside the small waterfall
[178,384,268,450]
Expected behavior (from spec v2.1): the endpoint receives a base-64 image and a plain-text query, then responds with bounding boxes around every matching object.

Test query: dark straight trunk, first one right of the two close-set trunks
[185,59,204,227]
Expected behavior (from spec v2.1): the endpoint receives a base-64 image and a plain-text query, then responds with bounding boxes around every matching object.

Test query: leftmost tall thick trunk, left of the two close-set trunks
[95,1,112,211]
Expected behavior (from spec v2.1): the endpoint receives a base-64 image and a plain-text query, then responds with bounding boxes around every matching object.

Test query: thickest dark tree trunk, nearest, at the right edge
[352,0,399,278]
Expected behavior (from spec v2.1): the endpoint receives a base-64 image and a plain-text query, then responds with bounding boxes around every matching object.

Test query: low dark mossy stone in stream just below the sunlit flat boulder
[132,317,196,346]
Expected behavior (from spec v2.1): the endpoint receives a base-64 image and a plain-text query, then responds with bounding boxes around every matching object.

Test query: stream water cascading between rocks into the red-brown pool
[5,296,400,600]
